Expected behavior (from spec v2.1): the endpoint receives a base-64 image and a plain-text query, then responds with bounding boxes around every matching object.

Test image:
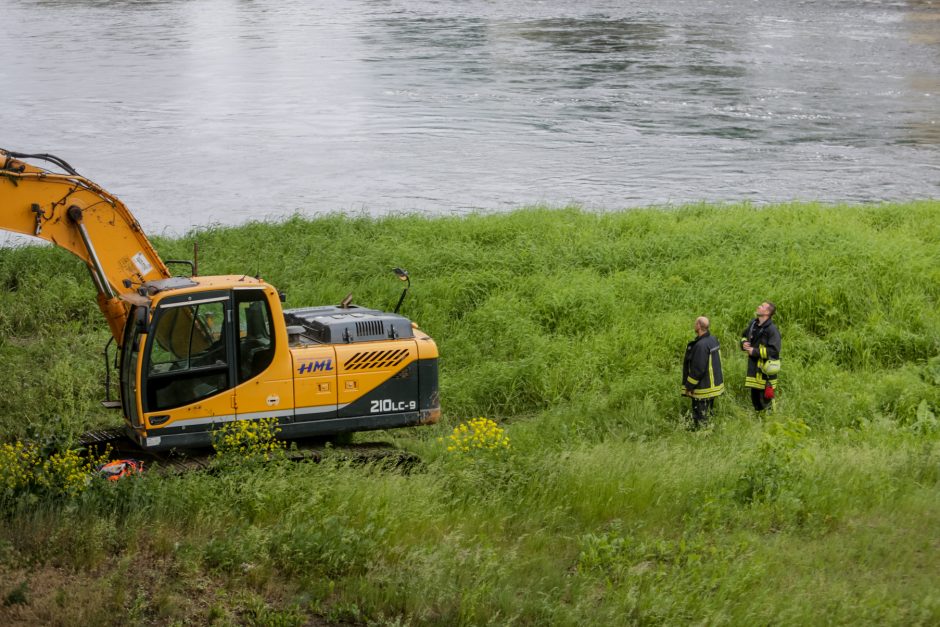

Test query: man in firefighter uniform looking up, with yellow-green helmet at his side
[741,301,780,412]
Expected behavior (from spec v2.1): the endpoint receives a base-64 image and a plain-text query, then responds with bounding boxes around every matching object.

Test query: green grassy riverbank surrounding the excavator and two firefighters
[0,202,940,625]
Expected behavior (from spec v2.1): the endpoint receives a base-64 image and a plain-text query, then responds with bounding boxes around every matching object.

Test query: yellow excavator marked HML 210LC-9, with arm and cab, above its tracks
[0,150,441,451]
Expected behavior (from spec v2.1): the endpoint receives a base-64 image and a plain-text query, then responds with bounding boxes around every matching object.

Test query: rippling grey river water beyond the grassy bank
[0,0,940,234]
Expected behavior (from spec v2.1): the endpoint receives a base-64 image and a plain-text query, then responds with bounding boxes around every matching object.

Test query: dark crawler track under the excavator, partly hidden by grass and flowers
[76,428,421,475]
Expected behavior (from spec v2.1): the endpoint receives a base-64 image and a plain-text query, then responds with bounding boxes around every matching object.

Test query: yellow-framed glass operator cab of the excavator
[121,279,291,444]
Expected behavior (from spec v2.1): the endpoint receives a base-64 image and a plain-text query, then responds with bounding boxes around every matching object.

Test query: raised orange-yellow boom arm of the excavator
[0,149,171,346]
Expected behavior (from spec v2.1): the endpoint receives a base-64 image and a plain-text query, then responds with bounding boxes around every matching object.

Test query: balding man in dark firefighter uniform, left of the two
[682,316,725,429]
